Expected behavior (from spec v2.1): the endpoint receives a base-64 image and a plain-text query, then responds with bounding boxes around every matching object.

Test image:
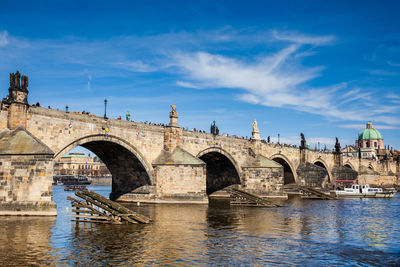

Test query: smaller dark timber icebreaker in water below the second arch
[230,188,281,207]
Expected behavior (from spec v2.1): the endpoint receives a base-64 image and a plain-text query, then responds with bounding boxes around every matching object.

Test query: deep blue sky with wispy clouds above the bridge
[0,0,400,149]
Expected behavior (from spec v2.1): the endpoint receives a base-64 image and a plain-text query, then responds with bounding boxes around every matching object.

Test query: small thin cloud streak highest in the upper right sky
[272,30,335,45]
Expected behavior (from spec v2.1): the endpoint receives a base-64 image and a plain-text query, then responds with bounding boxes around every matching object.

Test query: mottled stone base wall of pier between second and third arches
[242,167,283,196]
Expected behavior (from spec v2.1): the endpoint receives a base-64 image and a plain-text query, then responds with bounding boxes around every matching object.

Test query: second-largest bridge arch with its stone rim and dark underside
[197,147,241,195]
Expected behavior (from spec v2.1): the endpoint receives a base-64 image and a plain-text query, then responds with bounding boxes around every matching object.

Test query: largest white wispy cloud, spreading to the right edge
[173,49,400,124]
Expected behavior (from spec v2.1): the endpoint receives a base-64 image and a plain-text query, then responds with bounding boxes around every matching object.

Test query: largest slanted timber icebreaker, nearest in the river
[67,190,150,224]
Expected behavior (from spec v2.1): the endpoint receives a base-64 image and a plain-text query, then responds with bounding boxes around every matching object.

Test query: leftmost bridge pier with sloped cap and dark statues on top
[0,71,57,216]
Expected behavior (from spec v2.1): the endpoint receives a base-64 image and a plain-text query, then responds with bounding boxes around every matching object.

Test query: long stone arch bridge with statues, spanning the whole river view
[0,71,399,216]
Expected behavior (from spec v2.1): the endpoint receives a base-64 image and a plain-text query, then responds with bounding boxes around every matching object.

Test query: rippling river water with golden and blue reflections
[0,186,400,266]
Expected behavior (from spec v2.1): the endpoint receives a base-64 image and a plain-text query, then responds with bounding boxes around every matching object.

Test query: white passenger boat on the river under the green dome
[335,184,396,198]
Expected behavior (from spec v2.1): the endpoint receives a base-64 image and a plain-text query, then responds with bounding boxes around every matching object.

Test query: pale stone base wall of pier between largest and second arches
[154,165,207,201]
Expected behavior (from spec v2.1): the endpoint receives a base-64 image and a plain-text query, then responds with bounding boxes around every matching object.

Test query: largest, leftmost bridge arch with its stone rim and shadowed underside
[54,134,154,199]
